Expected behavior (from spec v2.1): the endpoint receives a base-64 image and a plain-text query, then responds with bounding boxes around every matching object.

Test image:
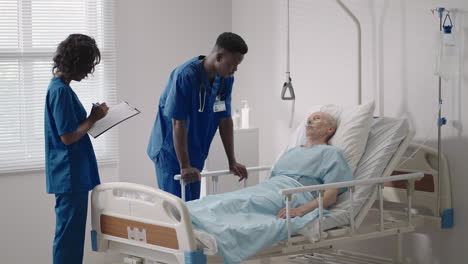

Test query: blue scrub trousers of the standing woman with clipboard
[53,192,88,264]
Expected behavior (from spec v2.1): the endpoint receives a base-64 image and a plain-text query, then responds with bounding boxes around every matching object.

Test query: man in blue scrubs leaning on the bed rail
[147,32,248,201]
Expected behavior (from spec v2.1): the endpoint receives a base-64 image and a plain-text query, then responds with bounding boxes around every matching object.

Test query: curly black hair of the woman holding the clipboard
[52,34,101,78]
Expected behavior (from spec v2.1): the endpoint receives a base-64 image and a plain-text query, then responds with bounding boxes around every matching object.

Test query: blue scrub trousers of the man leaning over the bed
[155,164,201,201]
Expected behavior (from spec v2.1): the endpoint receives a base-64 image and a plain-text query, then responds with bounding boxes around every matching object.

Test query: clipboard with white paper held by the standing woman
[88,102,141,138]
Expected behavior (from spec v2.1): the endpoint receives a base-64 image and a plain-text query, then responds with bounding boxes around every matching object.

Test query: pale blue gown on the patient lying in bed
[271,145,353,197]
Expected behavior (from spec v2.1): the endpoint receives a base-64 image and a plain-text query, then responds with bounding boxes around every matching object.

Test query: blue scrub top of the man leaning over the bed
[147,56,234,174]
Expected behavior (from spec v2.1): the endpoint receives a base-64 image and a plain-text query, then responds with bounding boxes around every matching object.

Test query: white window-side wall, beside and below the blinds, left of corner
[0,0,231,264]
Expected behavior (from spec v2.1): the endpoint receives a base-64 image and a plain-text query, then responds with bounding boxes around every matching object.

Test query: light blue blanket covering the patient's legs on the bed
[187,175,326,263]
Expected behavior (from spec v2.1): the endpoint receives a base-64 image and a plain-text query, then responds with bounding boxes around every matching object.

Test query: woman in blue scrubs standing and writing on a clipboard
[44,34,109,264]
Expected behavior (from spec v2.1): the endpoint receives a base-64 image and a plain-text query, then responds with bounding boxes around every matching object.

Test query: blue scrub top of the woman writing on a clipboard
[44,78,100,193]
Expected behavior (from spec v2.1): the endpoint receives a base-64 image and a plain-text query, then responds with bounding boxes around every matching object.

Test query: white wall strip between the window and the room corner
[116,0,231,187]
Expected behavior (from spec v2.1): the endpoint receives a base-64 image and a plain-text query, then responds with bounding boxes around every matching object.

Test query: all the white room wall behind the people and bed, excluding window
[0,0,468,263]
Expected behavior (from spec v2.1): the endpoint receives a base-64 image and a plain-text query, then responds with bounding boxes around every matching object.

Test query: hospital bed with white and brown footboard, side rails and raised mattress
[91,117,451,263]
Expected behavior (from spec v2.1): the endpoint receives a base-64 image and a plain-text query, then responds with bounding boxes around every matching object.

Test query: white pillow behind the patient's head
[287,101,375,173]
